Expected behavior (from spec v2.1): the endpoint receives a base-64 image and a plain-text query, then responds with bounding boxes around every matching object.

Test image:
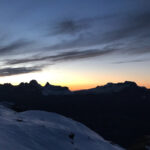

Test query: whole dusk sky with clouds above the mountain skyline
[0,0,150,90]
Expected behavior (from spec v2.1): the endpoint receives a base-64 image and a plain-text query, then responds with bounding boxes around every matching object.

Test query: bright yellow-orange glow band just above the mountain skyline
[0,70,150,91]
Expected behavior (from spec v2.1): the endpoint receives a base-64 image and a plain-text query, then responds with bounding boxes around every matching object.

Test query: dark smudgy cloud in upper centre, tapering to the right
[49,15,108,35]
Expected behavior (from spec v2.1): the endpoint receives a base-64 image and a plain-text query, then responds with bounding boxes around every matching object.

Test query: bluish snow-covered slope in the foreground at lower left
[0,105,122,150]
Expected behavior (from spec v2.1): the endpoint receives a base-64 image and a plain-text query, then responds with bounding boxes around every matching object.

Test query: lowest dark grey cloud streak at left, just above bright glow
[0,67,41,77]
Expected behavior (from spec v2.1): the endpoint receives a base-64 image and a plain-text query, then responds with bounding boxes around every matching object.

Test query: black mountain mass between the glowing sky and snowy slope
[0,80,150,148]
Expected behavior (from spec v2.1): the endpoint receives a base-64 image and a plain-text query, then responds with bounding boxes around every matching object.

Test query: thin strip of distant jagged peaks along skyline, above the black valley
[0,80,149,96]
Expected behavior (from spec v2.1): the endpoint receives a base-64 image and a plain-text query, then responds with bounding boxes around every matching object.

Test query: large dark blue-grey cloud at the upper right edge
[103,12,150,42]
